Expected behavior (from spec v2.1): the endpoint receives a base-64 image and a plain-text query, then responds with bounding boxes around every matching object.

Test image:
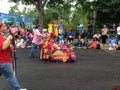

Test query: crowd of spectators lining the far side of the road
[6,17,120,50]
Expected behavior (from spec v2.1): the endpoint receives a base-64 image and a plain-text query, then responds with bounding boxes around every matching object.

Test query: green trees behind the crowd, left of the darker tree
[10,0,93,32]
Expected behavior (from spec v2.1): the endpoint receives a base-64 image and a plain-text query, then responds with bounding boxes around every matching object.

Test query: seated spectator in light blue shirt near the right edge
[108,36,117,50]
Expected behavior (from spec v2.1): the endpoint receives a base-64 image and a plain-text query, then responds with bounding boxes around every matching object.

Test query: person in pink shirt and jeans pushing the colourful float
[29,25,44,58]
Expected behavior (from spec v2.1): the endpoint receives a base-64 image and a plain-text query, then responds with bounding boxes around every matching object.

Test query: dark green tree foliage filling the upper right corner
[91,0,120,27]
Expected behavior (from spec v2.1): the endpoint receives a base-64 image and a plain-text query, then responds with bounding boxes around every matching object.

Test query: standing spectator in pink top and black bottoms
[101,25,108,46]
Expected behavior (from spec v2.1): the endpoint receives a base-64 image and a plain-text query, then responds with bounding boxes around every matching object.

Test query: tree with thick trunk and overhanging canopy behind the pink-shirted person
[9,0,74,26]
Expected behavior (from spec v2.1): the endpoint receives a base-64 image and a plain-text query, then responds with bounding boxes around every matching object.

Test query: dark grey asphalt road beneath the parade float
[0,49,120,90]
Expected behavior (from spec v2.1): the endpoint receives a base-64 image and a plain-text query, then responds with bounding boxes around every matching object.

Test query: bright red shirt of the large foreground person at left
[0,35,11,63]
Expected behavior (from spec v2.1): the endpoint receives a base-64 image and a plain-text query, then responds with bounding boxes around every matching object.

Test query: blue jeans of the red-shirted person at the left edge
[0,63,21,90]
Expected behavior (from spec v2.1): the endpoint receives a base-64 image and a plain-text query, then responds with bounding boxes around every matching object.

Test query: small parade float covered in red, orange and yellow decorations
[40,33,76,62]
